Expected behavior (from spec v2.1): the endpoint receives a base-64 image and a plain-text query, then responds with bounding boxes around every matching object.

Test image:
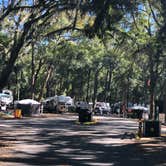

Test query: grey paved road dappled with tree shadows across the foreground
[0,115,166,166]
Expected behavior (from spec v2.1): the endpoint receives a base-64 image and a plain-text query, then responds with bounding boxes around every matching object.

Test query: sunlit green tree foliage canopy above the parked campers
[0,0,166,108]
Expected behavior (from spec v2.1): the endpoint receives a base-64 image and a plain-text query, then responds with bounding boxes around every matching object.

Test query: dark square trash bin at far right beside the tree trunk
[143,120,161,137]
